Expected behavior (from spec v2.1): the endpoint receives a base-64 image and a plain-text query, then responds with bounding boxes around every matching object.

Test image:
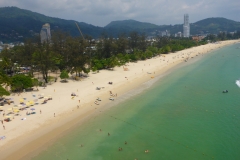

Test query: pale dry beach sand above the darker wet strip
[0,40,239,159]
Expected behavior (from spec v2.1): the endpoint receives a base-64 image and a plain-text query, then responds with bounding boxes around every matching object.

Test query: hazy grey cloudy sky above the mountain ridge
[0,0,240,26]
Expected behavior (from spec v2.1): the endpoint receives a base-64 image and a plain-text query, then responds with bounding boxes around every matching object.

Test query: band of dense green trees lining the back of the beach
[0,31,206,85]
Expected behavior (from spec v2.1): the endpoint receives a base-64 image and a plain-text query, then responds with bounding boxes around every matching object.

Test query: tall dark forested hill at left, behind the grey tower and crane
[0,7,102,41]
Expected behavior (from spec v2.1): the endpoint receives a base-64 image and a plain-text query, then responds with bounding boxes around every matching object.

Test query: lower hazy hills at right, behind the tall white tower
[105,18,240,35]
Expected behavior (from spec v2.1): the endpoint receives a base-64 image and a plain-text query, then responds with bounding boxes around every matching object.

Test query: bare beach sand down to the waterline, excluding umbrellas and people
[0,40,239,159]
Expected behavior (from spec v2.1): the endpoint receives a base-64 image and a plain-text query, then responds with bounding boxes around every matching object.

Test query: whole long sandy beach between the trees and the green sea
[0,40,240,159]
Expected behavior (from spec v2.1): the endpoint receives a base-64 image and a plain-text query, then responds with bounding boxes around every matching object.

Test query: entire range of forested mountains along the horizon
[0,7,240,42]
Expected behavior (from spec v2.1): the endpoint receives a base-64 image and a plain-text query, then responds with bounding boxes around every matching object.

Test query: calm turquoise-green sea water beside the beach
[33,44,240,160]
